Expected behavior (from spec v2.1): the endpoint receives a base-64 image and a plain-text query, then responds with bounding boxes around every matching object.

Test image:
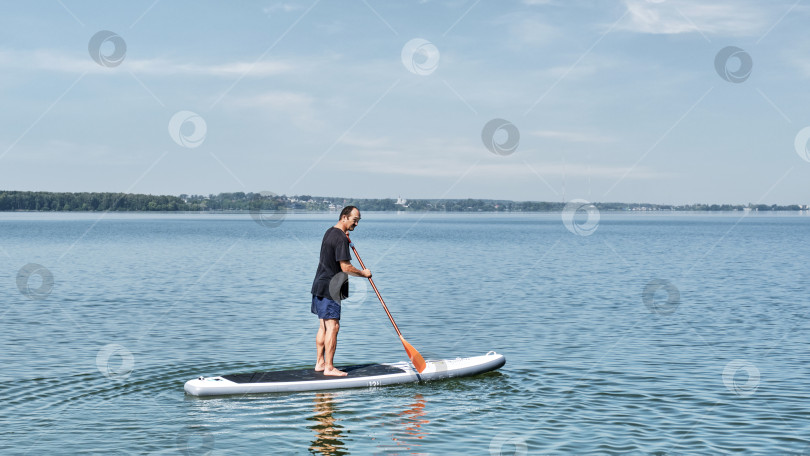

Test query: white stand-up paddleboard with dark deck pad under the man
[184,352,506,396]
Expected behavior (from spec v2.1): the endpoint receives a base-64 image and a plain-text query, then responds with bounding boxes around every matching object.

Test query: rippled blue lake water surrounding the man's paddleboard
[0,212,810,455]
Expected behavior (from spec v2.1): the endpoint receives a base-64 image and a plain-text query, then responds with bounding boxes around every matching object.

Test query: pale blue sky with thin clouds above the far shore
[0,0,810,204]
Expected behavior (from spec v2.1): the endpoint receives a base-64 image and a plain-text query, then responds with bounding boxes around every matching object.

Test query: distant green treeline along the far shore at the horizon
[0,191,808,212]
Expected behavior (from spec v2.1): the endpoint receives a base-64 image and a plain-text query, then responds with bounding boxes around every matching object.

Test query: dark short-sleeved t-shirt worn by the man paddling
[312,226,352,301]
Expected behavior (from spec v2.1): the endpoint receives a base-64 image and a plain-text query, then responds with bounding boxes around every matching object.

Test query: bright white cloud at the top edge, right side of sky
[620,0,780,36]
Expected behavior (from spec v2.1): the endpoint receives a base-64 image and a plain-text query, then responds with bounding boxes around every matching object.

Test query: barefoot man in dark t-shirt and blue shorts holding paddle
[312,206,371,377]
